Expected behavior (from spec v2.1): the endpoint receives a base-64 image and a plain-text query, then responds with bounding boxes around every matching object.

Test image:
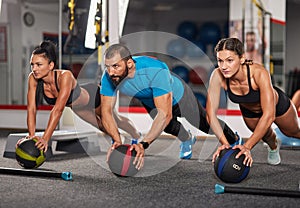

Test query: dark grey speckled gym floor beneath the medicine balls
[0,133,300,208]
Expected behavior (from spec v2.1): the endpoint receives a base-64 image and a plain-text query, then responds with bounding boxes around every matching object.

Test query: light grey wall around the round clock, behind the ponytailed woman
[0,0,68,104]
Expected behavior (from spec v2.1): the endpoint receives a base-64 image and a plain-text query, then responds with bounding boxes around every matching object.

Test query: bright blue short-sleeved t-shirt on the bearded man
[100,56,184,108]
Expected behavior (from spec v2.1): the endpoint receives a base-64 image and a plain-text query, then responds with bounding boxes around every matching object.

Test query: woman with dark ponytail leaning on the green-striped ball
[18,41,140,151]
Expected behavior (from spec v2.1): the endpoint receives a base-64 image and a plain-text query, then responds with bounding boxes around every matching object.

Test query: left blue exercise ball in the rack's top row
[177,21,198,40]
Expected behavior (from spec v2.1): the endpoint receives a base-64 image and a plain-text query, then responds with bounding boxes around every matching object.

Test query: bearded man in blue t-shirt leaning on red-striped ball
[100,44,236,168]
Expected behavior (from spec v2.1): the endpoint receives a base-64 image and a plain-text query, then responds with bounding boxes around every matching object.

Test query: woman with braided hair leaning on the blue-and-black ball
[206,38,300,166]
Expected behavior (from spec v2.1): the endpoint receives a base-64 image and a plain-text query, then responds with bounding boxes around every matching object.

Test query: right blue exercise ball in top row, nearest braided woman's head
[199,22,221,45]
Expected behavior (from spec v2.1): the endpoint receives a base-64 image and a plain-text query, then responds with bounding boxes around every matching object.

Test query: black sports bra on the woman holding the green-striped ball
[39,71,81,105]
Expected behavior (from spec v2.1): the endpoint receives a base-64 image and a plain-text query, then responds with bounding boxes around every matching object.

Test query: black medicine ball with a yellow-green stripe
[16,138,46,169]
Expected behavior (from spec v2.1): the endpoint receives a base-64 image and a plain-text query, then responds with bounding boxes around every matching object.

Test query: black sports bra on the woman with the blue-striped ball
[226,64,260,103]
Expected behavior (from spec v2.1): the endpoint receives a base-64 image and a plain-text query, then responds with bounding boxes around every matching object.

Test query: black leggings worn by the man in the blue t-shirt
[143,82,236,144]
